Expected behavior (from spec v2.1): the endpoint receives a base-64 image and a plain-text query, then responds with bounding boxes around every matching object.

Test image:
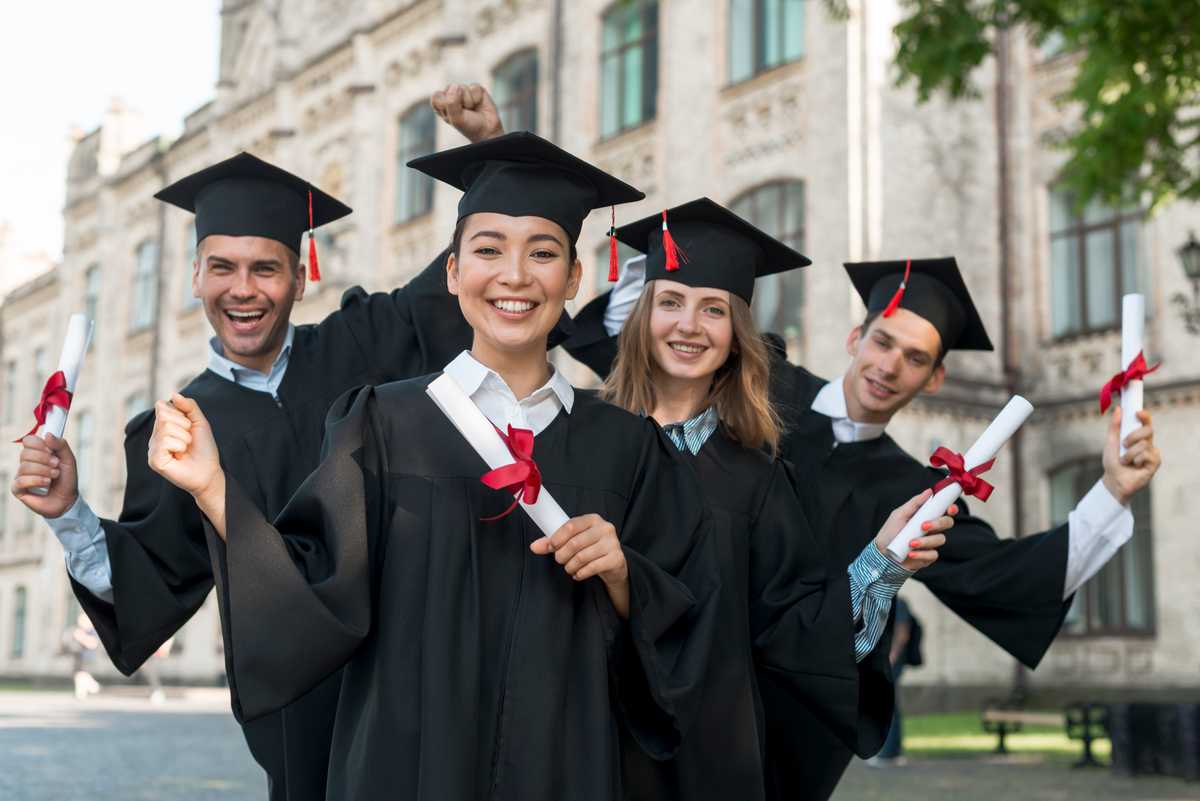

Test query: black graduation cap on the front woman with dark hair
[408,131,646,242]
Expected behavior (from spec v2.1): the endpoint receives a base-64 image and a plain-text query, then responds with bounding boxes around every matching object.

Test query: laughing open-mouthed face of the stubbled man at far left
[192,234,305,372]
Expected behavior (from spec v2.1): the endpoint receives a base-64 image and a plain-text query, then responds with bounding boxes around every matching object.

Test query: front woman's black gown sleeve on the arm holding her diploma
[606,420,721,759]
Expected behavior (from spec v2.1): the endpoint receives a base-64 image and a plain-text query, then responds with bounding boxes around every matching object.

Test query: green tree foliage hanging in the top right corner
[895,0,1200,207]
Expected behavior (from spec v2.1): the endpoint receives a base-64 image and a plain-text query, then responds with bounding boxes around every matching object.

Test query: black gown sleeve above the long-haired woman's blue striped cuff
[748,462,893,755]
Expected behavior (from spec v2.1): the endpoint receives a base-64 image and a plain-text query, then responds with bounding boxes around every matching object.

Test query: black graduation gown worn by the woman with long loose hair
[624,429,892,801]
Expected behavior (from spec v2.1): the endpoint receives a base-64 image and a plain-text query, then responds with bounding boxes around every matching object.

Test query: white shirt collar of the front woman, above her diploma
[444,350,575,436]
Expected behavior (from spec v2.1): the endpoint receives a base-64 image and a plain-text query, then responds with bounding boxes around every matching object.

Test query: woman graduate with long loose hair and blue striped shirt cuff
[585,198,952,801]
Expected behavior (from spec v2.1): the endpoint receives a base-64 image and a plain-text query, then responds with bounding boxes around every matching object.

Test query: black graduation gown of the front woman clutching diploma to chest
[210,377,719,801]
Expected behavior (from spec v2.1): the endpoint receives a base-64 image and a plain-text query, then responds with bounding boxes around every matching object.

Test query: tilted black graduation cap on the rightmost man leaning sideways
[845,257,994,350]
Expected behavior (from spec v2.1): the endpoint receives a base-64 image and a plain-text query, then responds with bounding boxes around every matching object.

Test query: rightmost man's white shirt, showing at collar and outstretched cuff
[812,377,1133,601]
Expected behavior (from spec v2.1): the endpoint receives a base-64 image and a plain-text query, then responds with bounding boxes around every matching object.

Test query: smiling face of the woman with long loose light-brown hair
[650,278,733,386]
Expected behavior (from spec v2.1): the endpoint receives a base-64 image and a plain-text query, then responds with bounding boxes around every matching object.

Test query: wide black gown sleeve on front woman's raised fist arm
[205,387,386,721]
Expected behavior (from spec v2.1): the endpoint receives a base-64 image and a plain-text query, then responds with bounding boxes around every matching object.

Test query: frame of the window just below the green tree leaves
[1046,185,1146,342]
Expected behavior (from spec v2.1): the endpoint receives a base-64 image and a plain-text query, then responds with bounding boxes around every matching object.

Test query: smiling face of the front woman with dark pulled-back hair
[446,212,582,363]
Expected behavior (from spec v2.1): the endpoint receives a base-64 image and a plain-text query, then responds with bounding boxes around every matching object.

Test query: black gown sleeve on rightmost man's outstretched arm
[914,500,1074,669]
